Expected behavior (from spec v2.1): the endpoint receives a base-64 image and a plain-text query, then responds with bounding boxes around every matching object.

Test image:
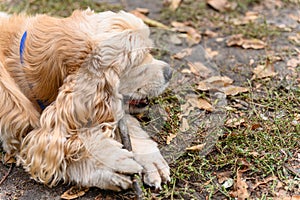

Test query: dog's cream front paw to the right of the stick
[134,151,170,189]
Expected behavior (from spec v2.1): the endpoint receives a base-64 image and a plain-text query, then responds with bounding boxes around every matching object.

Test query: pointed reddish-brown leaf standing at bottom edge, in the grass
[230,170,250,199]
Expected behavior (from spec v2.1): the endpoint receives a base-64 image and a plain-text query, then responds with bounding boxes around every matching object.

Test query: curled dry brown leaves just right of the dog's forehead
[171,21,201,46]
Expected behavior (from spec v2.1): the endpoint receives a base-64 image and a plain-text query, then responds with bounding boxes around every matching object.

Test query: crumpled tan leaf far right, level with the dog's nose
[251,60,277,80]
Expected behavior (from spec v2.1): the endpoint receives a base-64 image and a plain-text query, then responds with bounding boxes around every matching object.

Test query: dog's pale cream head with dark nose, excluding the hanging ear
[83,11,172,111]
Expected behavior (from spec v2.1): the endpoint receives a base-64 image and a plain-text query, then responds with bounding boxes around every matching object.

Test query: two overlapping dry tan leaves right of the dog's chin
[197,76,249,96]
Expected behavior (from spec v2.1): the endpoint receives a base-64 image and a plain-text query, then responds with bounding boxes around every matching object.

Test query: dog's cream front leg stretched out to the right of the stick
[124,115,170,188]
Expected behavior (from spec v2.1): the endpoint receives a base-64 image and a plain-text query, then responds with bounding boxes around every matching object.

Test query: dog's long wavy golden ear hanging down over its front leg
[20,68,122,186]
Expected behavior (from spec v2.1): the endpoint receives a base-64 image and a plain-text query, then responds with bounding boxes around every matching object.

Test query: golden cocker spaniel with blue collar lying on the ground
[0,9,172,191]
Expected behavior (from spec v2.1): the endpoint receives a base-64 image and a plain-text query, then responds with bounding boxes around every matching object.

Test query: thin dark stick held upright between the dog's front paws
[119,117,143,200]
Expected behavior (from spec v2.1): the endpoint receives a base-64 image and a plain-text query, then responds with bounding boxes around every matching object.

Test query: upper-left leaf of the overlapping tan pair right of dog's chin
[197,76,233,91]
